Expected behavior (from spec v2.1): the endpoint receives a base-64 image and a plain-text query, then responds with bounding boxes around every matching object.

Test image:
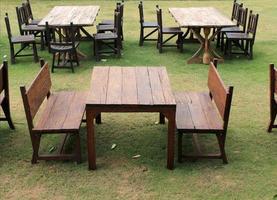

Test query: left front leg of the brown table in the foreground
[86,109,96,170]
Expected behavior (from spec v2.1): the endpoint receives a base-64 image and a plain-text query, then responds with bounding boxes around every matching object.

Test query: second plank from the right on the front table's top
[148,67,165,105]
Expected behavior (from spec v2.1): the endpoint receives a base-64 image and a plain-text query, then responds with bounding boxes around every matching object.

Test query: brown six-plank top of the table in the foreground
[87,66,176,106]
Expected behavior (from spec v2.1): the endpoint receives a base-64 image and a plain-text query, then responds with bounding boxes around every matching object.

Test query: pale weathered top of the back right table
[169,7,235,28]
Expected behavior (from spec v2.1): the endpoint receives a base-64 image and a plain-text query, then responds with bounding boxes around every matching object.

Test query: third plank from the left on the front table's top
[121,67,138,105]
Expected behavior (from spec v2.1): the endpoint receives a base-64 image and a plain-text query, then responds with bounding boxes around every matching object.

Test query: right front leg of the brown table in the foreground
[165,110,176,170]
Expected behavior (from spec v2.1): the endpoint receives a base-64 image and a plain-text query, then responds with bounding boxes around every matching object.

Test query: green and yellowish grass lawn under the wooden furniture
[0,0,277,199]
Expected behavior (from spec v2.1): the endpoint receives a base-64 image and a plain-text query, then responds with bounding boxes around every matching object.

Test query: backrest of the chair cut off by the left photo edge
[0,61,9,104]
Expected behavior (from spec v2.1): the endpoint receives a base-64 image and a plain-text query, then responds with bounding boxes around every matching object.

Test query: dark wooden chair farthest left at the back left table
[5,13,38,64]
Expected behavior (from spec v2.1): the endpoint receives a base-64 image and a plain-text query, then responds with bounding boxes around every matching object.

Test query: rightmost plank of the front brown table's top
[159,67,176,105]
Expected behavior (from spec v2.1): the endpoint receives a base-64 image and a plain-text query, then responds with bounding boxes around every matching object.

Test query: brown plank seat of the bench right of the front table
[175,92,223,133]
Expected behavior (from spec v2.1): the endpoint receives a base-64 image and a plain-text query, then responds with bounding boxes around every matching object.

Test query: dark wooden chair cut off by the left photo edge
[0,61,15,130]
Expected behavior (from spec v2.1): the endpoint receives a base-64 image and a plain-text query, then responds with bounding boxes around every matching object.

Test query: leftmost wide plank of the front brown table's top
[87,67,110,104]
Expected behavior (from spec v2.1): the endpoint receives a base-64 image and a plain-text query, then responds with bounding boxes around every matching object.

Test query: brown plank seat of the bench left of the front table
[33,91,87,133]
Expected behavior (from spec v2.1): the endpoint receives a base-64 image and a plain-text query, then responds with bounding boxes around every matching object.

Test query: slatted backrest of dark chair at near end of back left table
[45,22,76,52]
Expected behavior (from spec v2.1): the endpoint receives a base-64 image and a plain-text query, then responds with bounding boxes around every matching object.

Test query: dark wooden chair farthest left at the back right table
[138,1,158,46]
